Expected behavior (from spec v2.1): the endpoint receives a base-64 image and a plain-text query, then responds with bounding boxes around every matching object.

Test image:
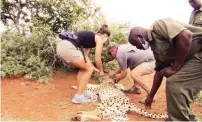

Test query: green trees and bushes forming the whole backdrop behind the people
[1,0,129,82]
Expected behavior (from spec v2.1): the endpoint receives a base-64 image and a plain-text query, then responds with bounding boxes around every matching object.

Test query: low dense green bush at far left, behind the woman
[1,26,58,81]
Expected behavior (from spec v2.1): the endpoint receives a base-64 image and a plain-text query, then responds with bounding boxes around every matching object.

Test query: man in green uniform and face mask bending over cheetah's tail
[129,18,202,121]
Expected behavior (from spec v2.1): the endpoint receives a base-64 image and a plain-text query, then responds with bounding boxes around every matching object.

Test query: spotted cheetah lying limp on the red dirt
[72,77,168,121]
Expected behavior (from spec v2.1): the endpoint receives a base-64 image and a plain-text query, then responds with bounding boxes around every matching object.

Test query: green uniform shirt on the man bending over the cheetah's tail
[148,18,202,71]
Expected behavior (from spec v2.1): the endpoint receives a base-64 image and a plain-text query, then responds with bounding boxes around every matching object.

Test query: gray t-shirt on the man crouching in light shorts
[116,43,155,69]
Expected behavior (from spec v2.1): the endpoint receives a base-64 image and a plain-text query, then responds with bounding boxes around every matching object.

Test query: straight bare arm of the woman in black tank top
[95,35,104,75]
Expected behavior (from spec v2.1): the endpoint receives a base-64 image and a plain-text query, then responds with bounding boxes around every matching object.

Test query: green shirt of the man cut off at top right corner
[189,7,202,27]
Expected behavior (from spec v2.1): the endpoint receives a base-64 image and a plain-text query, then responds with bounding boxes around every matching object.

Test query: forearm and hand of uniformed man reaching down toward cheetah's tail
[145,71,163,109]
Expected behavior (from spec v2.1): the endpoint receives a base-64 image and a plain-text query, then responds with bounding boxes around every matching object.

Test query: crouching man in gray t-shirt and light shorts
[108,44,155,99]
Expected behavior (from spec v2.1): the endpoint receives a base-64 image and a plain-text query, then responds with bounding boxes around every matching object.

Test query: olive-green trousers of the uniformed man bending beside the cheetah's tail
[166,52,202,121]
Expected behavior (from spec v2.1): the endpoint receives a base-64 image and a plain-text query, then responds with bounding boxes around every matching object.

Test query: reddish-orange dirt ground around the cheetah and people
[1,72,202,121]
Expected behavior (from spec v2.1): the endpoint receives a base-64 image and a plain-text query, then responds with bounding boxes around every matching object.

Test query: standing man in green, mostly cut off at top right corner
[188,0,202,27]
